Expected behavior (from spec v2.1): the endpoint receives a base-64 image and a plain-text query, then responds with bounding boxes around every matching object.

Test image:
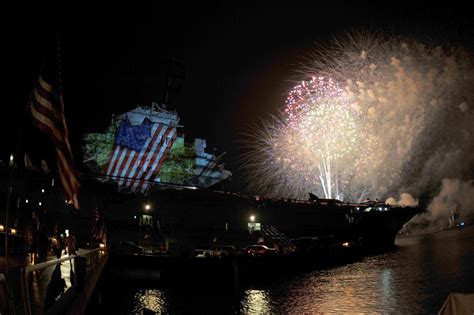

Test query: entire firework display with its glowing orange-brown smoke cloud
[242,34,474,201]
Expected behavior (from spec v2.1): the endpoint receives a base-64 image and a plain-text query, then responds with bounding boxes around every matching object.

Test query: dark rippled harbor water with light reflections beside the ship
[88,226,474,314]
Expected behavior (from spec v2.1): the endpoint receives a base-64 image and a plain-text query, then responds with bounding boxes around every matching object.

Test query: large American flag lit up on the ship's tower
[104,115,177,193]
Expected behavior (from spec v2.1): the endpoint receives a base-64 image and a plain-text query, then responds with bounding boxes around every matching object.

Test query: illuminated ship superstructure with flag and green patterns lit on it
[84,103,232,194]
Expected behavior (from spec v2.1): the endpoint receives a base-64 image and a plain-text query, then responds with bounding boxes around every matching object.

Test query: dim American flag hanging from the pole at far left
[30,62,79,209]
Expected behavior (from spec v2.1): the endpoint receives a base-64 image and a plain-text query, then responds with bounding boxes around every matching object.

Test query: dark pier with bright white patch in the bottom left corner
[0,248,108,315]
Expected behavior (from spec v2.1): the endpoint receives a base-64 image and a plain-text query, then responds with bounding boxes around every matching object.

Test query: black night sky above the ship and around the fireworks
[4,1,474,193]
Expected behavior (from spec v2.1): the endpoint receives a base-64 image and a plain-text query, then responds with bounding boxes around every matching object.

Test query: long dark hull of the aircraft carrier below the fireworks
[100,186,419,255]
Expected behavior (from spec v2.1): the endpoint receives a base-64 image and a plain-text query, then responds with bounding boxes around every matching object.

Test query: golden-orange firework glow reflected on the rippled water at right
[241,227,474,314]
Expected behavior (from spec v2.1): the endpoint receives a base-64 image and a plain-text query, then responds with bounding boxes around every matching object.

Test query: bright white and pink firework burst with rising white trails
[245,77,362,199]
